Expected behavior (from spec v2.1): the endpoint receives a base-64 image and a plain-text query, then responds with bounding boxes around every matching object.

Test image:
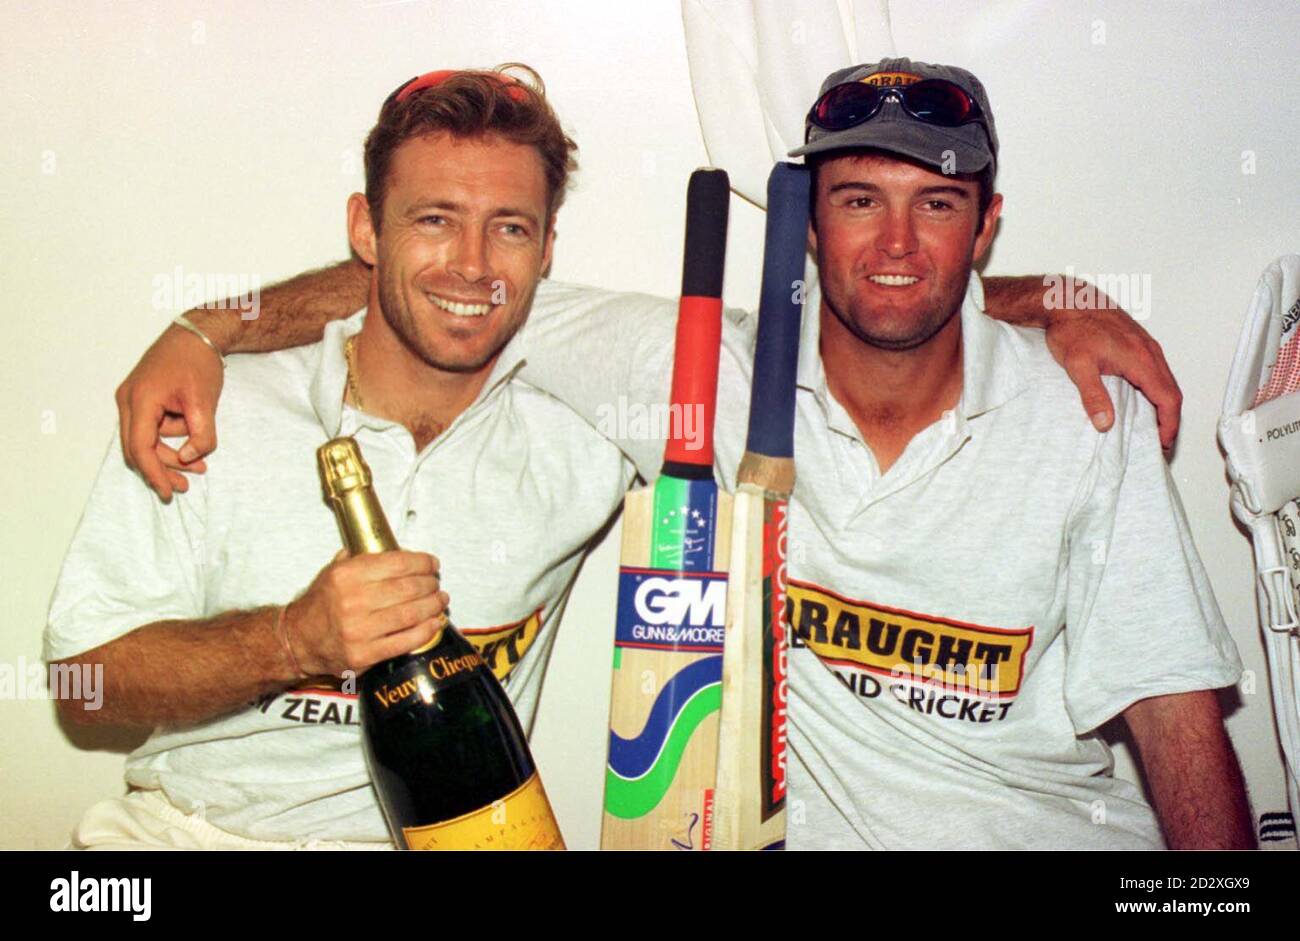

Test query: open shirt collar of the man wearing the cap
[798,272,1024,434]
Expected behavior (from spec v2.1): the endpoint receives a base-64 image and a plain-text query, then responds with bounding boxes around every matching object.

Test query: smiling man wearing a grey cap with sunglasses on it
[104,60,1252,849]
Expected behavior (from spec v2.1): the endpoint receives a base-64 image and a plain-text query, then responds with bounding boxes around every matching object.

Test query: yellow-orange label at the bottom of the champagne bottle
[402,771,564,850]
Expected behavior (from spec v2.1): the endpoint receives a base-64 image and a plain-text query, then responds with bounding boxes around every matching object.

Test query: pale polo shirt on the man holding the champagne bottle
[44,311,633,841]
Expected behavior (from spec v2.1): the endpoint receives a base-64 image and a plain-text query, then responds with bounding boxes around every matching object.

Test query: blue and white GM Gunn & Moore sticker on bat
[614,565,727,654]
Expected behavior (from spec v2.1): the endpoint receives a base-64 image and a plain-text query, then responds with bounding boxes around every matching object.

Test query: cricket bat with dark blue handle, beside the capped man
[711,162,809,850]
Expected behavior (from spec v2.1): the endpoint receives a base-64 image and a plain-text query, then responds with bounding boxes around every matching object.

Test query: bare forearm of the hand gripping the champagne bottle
[57,607,299,728]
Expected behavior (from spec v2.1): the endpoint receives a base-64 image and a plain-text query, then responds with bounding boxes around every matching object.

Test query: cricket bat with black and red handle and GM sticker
[601,169,731,850]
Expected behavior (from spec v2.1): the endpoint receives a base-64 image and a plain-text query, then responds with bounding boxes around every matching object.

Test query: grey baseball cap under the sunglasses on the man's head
[790,58,997,173]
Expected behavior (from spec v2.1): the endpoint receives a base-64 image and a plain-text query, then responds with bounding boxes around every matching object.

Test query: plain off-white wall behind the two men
[0,0,1300,849]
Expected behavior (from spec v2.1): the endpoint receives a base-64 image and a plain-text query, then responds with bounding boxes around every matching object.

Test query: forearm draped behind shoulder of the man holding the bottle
[186,257,371,354]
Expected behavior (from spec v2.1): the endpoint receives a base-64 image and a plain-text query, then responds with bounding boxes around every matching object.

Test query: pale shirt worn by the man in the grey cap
[521,274,1240,849]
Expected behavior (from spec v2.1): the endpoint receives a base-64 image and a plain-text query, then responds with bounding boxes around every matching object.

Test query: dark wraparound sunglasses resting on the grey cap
[803,78,993,149]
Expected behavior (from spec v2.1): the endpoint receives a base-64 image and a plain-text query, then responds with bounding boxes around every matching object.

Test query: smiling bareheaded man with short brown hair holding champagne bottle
[46,64,632,849]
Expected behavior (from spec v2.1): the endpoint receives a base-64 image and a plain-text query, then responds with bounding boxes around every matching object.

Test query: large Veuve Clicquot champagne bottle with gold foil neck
[317,438,564,850]
